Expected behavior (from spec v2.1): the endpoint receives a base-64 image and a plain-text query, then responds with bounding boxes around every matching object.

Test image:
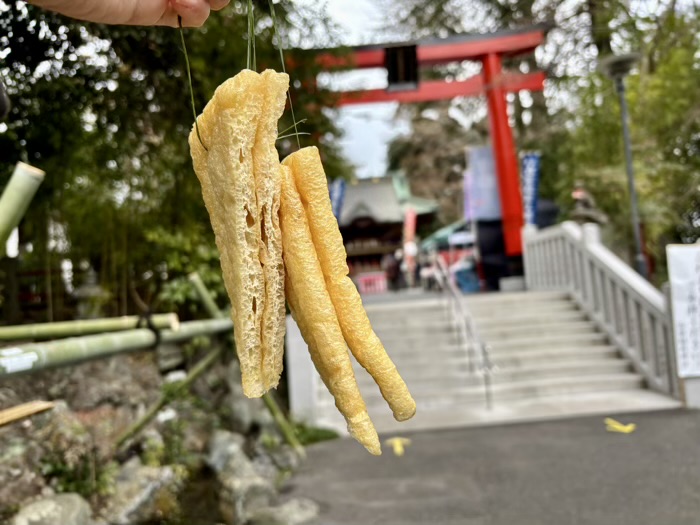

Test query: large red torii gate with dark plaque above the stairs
[318,25,550,256]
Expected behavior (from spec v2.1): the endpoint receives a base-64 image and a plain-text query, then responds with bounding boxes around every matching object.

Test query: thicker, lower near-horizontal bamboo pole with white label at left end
[0,319,233,379]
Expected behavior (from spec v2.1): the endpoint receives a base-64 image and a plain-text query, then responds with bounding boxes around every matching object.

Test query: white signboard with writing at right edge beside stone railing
[666,244,700,377]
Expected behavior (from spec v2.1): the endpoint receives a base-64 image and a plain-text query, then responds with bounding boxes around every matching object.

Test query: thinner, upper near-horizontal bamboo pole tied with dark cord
[0,313,180,341]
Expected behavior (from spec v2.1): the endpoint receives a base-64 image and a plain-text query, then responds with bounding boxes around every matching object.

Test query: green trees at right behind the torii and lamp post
[391,0,700,279]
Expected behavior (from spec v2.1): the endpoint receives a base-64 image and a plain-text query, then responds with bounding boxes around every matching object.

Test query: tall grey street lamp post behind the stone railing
[598,53,649,279]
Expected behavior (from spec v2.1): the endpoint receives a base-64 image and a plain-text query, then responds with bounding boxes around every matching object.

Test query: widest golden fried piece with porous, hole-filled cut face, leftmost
[189,70,288,397]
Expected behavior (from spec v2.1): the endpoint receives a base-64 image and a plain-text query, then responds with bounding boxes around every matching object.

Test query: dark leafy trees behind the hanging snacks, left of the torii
[0,0,350,315]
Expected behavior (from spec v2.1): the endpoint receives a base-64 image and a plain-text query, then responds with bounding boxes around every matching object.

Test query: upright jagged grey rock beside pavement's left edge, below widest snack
[207,430,275,525]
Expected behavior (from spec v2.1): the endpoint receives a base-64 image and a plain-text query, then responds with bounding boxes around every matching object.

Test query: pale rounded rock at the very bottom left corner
[10,493,93,525]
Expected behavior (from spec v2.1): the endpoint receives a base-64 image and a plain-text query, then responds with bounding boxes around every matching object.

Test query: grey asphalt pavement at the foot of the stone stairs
[291,410,700,525]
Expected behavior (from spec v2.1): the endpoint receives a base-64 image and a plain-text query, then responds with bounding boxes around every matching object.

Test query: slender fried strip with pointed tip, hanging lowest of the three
[280,166,381,455]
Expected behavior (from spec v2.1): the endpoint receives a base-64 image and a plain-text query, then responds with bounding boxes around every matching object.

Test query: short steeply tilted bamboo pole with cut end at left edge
[0,162,45,248]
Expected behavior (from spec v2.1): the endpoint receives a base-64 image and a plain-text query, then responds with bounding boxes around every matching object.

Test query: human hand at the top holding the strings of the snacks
[30,0,229,27]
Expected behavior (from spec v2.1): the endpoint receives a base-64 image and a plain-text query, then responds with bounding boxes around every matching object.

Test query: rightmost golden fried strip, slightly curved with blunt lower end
[283,147,416,421]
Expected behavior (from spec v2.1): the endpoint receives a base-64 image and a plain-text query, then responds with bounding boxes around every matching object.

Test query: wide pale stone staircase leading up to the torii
[292,292,679,433]
